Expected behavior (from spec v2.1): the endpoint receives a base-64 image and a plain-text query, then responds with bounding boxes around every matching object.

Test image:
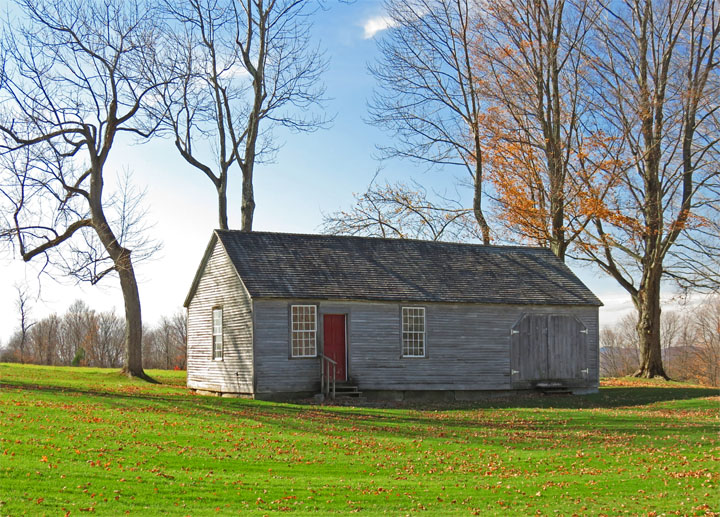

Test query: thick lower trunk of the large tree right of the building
[633,269,669,379]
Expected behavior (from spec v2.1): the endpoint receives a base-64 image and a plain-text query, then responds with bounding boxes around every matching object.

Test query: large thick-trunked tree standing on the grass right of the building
[583,0,720,378]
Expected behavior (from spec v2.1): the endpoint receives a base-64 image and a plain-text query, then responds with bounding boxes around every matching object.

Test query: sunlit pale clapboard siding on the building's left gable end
[187,242,253,394]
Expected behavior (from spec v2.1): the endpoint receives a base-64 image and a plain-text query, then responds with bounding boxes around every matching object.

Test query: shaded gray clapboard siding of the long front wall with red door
[254,300,598,393]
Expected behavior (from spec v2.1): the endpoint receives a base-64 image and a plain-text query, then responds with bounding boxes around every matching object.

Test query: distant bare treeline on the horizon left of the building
[0,300,186,370]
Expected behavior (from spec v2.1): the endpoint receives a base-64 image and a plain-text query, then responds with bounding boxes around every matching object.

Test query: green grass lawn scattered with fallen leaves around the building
[0,364,720,515]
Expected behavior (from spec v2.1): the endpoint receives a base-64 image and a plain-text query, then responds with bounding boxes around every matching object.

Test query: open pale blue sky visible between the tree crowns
[0,0,630,343]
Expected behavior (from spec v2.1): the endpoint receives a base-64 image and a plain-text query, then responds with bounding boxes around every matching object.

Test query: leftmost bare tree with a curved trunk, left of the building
[0,0,165,377]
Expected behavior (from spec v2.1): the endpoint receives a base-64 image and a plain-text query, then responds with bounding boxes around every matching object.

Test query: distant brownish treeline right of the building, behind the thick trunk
[600,296,720,386]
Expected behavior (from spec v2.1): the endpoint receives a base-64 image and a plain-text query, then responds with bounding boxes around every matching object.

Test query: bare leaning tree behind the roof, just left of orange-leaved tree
[370,0,490,244]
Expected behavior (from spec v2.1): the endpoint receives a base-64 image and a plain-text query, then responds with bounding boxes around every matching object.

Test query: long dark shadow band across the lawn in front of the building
[0,374,718,441]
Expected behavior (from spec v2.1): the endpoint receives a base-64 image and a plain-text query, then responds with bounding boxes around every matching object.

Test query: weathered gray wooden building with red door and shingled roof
[185,230,602,400]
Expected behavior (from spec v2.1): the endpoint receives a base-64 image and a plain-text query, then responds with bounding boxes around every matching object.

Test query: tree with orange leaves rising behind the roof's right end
[473,0,621,260]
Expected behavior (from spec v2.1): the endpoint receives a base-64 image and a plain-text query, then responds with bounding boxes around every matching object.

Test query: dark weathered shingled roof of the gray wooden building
[185,230,602,306]
